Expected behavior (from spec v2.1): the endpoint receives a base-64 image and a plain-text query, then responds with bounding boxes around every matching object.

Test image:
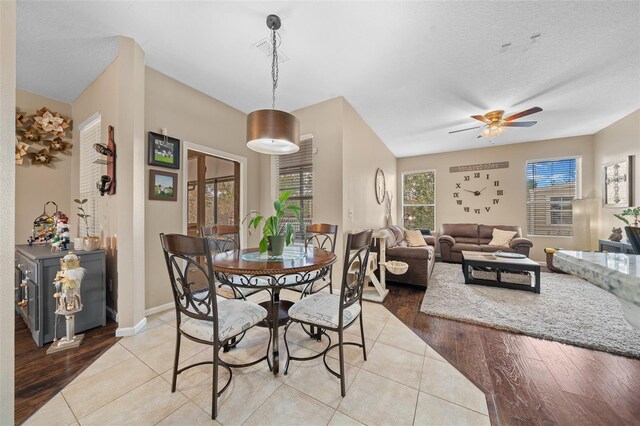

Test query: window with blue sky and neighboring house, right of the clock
[527,158,580,237]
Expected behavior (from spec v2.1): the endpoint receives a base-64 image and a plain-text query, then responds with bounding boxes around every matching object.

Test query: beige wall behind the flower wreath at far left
[15,90,73,240]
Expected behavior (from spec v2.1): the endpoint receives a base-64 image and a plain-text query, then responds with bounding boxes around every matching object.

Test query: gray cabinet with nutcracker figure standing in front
[15,245,106,346]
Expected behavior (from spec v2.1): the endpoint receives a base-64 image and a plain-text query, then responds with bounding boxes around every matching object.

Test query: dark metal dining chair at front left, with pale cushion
[160,234,267,419]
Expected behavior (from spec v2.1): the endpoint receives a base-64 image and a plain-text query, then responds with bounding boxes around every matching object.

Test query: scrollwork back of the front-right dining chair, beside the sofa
[338,229,373,327]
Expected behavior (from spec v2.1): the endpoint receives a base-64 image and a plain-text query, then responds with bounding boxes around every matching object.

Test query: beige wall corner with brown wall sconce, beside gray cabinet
[71,37,146,335]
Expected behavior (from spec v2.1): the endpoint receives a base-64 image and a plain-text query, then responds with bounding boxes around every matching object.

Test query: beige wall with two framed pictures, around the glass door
[145,67,260,308]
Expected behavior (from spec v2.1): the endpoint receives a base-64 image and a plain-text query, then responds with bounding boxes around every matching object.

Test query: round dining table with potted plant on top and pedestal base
[213,246,336,375]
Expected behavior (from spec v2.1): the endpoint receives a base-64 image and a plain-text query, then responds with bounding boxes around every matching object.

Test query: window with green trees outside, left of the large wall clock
[402,170,436,229]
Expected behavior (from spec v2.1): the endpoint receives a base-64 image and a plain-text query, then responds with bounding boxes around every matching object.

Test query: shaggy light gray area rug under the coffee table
[420,263,640,358]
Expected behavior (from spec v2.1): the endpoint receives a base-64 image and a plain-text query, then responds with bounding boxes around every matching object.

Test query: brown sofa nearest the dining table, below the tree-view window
[375,225,436,287]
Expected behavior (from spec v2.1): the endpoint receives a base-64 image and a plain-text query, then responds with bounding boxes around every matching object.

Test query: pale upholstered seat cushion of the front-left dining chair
[180,298,267,342]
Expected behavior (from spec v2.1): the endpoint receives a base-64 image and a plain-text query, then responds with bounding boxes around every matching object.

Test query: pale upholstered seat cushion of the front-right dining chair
[289,292,361,329]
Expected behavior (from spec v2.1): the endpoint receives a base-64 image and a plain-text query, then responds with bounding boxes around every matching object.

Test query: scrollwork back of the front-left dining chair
[160,234,218,340]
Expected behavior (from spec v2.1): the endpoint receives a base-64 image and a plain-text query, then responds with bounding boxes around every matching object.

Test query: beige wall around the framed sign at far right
[594,110,640,239]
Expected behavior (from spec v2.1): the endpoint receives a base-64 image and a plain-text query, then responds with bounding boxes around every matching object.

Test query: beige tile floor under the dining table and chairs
[25,292,490,426]
